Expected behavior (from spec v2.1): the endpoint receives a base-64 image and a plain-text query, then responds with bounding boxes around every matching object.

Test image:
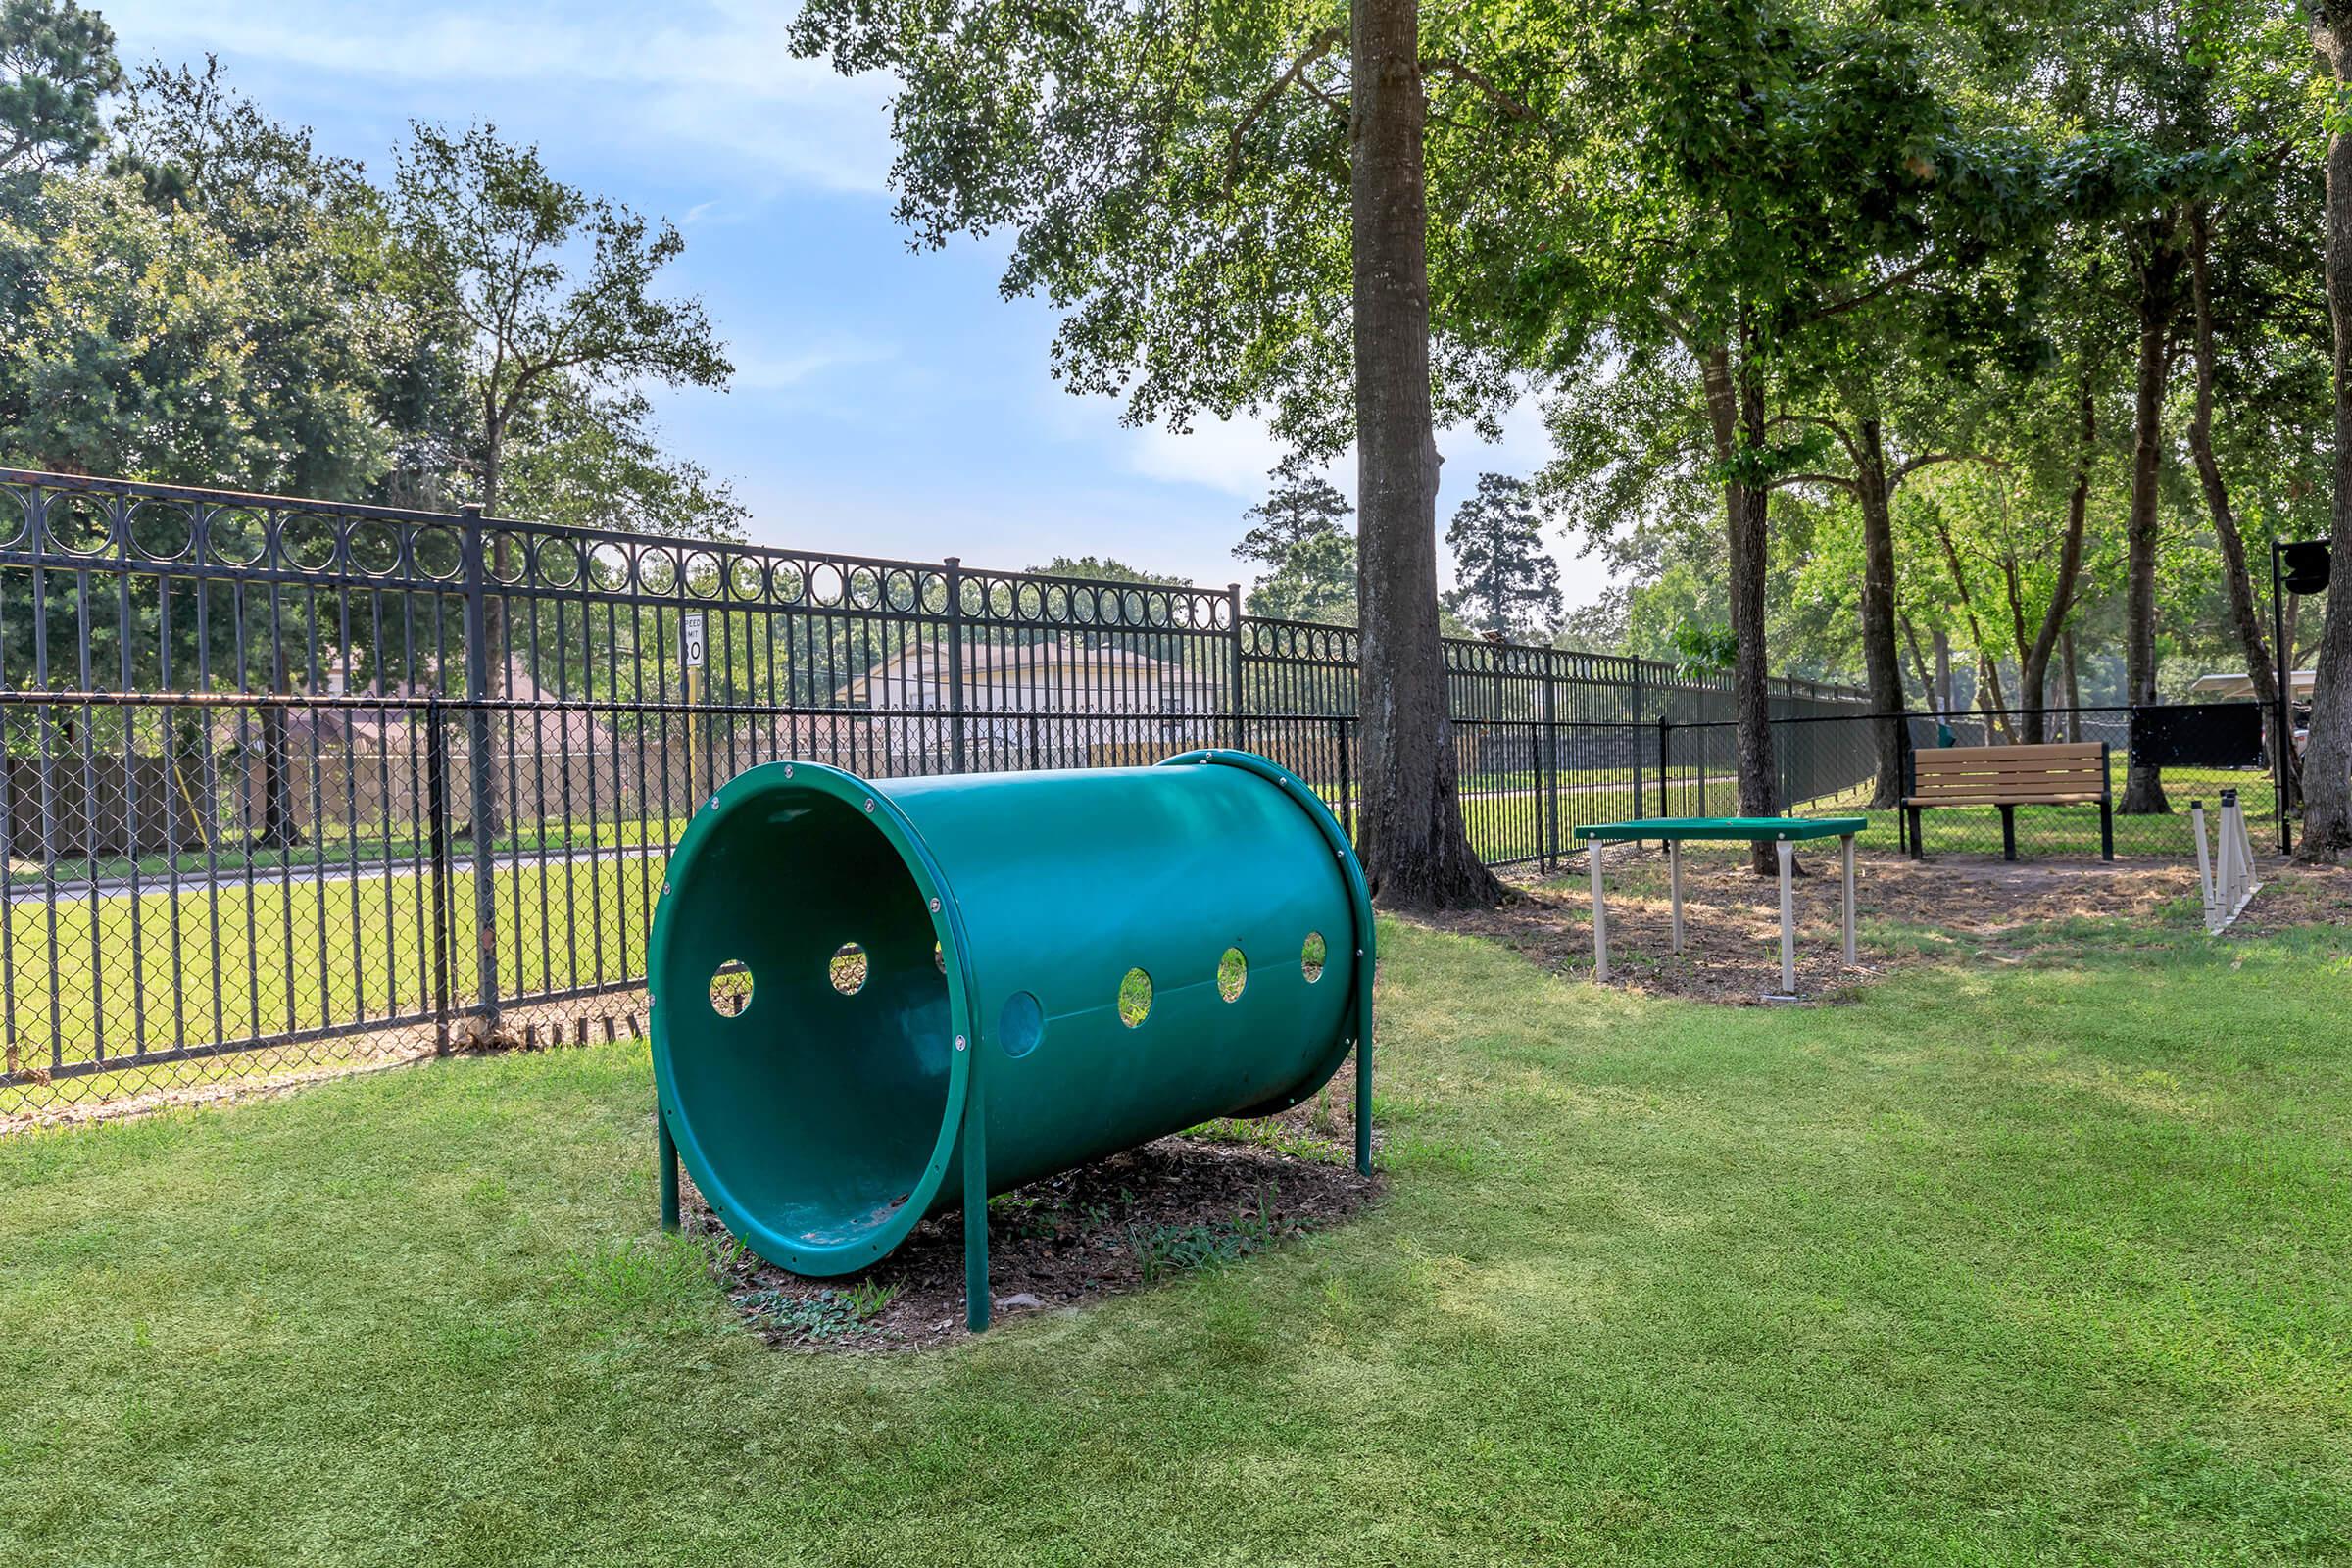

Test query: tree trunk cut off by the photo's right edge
[2298,0,2352,862]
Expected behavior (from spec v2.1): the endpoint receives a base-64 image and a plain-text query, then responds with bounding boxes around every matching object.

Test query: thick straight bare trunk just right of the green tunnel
[1348,0,1503,909]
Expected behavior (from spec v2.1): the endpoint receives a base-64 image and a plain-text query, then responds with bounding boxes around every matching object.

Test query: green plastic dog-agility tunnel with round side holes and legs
[647,750,1374,1328]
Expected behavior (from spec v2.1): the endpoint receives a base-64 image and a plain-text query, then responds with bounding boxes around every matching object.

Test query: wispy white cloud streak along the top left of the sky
[106,0,892,190]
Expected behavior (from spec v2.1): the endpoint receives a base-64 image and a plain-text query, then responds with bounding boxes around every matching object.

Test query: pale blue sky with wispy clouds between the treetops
[99,0,1606,604]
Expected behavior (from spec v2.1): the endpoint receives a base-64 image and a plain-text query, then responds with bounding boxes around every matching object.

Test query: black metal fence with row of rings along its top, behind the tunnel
[0,470,1868,1119]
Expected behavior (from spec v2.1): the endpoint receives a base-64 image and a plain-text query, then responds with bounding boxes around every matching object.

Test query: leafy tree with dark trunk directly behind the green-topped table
[1522,0,1971,872]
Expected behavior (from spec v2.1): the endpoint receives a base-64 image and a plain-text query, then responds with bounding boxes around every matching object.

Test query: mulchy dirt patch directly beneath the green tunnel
[680,1102,1383,1354]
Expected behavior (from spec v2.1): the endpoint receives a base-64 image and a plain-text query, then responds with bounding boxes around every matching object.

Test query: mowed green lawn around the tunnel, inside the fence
[0,903,2352,1568]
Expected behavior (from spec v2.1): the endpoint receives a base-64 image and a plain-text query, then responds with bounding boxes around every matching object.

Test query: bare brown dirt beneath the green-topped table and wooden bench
[1430,849,2352,1004]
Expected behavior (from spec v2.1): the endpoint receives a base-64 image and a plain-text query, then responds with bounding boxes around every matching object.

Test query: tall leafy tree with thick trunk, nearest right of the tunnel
[795,0,1524,906]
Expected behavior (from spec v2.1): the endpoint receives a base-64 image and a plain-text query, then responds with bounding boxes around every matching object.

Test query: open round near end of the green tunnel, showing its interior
[652,768,959,1274]
